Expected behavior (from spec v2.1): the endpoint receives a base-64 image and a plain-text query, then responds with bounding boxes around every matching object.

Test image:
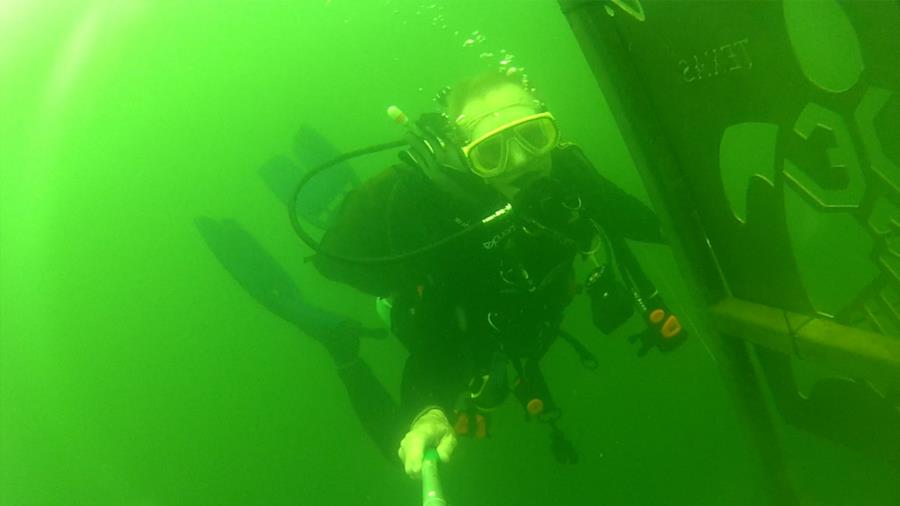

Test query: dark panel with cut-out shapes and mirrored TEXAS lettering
[560,0,900,504]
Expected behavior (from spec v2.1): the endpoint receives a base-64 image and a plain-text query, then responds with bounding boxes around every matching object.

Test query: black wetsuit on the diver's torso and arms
[315,145,661,422]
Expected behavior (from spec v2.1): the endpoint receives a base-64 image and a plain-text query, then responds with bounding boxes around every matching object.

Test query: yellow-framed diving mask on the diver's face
[462,112,559,178]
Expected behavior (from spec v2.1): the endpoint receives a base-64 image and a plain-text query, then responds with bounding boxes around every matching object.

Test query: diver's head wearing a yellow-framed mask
[447,72,559,199]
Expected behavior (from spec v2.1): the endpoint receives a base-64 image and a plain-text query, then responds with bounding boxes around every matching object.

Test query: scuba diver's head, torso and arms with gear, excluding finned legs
[306,72,685,477]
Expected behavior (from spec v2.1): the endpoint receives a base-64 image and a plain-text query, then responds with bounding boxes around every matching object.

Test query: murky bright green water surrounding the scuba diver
[0,0,900,506]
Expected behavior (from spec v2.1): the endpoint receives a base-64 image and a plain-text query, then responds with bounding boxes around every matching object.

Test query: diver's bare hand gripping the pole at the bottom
[397,408,456,479]
